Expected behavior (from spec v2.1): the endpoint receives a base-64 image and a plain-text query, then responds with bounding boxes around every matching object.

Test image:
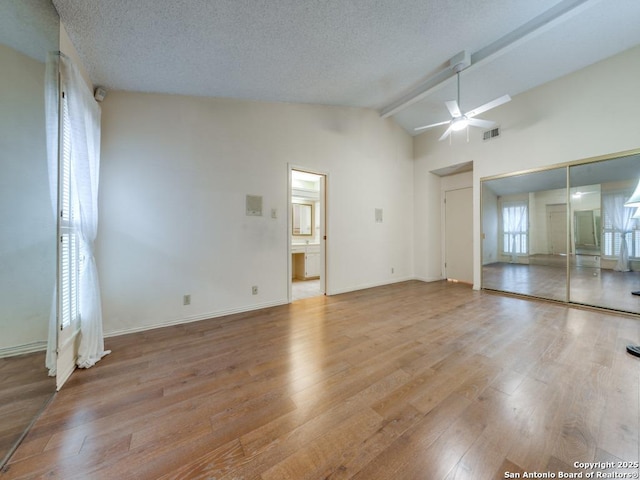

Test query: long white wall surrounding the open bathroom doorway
[97,92,414,335]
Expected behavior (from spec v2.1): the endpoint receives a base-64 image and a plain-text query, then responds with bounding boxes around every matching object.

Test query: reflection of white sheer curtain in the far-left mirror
[44,52,60,377]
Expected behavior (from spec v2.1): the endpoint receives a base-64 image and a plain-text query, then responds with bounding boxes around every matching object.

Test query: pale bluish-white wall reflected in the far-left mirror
[0,45,56,356]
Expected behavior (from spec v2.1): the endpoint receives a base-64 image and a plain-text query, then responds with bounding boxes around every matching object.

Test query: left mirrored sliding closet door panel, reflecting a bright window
[482,168,567,300]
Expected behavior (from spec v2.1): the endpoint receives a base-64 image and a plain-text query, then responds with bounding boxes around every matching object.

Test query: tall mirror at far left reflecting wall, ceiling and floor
[0,0,59,464]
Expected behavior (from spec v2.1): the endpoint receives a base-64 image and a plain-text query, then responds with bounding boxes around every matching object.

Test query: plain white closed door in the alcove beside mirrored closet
[444,187,473,283]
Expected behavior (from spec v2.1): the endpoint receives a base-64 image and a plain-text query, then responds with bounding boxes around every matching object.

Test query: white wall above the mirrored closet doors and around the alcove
[414,47,640,288]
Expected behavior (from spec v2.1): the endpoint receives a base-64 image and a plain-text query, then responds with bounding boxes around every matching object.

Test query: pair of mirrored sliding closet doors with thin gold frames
[482,154,640,313]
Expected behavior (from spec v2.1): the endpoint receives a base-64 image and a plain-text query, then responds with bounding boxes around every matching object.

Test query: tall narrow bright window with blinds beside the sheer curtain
[59,93,80,330]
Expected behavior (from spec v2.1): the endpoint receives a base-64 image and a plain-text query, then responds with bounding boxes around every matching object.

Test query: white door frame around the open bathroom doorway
[286,163,329,303]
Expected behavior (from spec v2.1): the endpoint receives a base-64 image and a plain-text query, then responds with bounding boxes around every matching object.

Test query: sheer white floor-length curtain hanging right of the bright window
[60,55,110,368]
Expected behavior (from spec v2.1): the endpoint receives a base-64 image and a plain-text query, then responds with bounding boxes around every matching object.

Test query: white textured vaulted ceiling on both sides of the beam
[53,0,640,132]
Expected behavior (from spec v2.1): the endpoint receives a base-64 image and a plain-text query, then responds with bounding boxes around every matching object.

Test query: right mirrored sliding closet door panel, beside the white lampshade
[569,155,640,313]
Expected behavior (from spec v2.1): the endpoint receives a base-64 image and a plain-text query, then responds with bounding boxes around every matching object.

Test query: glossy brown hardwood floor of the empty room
[0,281,640,480]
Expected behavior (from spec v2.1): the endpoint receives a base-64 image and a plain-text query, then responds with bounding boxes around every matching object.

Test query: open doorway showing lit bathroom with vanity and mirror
[288,167,327,302]
